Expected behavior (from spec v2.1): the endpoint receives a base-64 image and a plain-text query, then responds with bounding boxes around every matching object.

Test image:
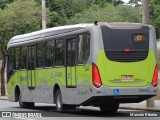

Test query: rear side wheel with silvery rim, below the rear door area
[56,89,66,112]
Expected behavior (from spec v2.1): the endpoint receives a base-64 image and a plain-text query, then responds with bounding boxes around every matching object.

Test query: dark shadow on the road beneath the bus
[12,106,130,117]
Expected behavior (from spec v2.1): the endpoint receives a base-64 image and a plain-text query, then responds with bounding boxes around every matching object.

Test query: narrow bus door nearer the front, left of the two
[27,46,36,89]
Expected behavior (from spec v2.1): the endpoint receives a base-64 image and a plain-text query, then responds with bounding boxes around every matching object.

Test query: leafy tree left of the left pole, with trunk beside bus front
[0,0,41,96]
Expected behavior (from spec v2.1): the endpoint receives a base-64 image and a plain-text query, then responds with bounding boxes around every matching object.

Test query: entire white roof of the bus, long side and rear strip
[7,22,147,48]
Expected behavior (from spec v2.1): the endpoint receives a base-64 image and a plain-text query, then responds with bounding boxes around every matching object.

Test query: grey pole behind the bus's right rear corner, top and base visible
[142,0,155,107]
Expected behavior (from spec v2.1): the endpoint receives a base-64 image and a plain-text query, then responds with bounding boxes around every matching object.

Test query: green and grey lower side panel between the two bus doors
[28,68,66,103]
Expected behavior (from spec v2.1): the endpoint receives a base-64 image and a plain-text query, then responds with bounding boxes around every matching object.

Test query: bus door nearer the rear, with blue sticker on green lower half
[66,38,76,88]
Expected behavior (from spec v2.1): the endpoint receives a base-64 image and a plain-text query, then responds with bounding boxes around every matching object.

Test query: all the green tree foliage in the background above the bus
[0,0,160,54]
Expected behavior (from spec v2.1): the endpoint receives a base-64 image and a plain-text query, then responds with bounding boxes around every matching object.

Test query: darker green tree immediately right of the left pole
[36,0,91,27]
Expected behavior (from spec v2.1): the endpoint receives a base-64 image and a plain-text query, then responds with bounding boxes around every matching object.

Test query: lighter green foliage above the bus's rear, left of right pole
[67,4,141,24]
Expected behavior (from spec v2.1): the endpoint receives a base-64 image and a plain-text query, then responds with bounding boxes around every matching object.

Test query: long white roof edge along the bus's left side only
[7,24,93,48]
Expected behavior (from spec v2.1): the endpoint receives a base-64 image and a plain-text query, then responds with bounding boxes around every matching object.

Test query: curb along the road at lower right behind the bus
[119,107,160,112]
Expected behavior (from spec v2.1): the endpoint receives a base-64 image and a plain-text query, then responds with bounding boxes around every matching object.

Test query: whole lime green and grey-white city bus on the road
[7,22,158,112]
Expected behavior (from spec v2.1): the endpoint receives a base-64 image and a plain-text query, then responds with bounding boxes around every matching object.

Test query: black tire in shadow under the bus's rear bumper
[100,103,119,113]
